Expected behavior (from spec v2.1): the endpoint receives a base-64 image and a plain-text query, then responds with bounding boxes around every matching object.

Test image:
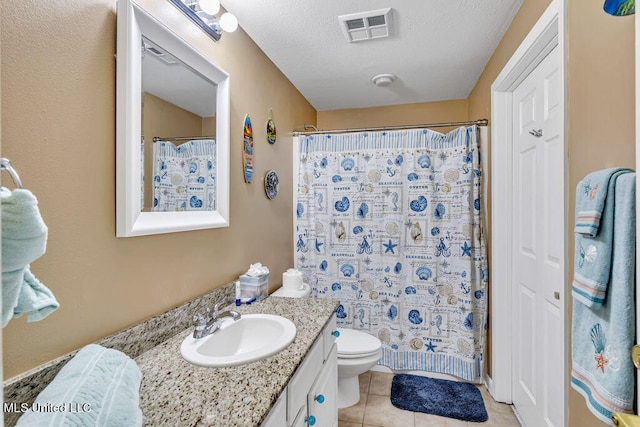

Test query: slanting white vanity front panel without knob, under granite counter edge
[287,337,324,421]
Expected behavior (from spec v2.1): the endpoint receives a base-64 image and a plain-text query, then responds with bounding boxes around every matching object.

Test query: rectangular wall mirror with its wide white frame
[116,0,229,237]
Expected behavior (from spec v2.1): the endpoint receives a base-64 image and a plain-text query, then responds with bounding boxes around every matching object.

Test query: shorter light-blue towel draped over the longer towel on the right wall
[571,168,633,307]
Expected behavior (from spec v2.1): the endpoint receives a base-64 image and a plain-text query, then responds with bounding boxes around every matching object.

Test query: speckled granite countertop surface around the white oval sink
[135,296,338,427]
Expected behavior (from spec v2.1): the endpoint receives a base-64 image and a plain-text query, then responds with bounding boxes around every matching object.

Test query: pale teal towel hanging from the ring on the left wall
[0,187,60,328]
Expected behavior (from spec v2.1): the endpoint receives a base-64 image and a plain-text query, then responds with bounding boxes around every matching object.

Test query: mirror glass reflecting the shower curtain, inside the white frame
[141,37,217,212]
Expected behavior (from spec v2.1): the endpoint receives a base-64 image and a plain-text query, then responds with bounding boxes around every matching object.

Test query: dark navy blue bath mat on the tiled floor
[391,374,489,423]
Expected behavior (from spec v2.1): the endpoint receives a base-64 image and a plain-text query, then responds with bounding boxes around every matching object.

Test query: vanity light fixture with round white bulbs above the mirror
[169,0,238,41]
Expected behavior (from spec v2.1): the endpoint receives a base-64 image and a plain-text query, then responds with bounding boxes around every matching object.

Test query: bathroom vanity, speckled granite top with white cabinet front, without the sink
[135,297,338,427]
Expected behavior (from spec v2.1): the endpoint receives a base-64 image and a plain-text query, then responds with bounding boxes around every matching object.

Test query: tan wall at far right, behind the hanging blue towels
[567,0,635,427]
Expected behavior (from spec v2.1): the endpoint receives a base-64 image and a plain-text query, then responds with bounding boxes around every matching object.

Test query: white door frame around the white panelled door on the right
[485,0,568,414]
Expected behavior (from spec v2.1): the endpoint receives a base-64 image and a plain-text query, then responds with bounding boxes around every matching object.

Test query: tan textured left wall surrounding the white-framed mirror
[0,0,316,378]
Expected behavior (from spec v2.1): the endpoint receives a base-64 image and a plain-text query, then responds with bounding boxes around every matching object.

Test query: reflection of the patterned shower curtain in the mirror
[153,139,216,212]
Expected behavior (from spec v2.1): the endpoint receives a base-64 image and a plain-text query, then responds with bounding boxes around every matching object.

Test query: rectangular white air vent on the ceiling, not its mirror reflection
[338,8,391,42]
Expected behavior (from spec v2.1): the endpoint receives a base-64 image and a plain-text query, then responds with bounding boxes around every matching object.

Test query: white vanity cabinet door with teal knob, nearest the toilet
[307,345,338,427]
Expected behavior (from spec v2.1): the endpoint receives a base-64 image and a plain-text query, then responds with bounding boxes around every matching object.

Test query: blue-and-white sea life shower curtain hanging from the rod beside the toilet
[294,126,487,382]
